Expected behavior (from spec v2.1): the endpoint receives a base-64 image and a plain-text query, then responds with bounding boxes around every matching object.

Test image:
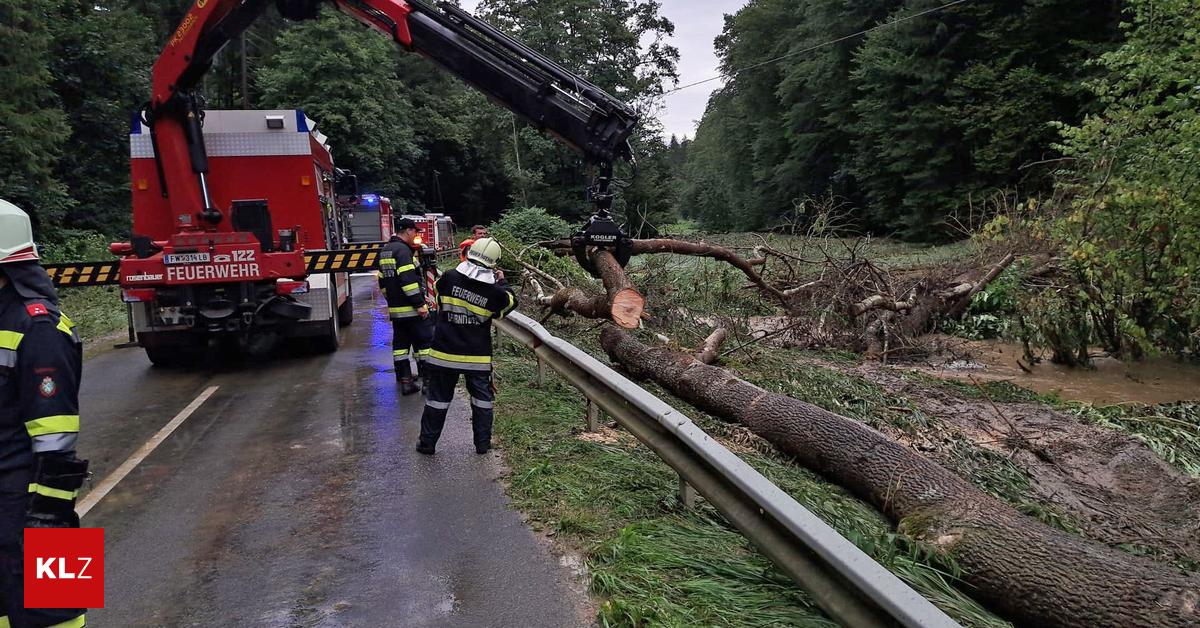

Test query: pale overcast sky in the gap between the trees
[462,0,746,138]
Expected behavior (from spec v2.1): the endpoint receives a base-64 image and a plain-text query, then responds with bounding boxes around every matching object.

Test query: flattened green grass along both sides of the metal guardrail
[496,338,1007,627]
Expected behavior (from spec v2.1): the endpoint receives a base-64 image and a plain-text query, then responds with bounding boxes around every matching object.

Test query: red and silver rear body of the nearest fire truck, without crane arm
[126,109,353,364]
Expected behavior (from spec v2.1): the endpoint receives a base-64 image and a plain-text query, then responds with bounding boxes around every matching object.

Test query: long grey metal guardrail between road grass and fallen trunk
[497,312,959,628]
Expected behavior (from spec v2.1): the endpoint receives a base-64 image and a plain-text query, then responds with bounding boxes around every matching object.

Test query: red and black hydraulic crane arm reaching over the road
[144,0,638,231]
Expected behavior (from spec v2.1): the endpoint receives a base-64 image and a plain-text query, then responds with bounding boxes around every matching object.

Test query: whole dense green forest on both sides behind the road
[0,0,1200,361]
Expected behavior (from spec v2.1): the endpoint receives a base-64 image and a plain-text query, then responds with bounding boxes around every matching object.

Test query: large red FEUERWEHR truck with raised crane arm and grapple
[48,0,638,364]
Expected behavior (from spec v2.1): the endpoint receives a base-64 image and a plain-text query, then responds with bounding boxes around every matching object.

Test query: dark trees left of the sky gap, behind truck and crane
[0,0,682,246]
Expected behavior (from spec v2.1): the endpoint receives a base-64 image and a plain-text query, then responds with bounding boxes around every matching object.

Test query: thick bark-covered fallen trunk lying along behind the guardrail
[601,327,1200,627]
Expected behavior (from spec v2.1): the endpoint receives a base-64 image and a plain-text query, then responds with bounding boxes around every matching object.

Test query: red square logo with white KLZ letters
[25,527,104,609]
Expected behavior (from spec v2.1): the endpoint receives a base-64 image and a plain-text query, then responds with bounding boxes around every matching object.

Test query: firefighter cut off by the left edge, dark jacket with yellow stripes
[0,201,88,628]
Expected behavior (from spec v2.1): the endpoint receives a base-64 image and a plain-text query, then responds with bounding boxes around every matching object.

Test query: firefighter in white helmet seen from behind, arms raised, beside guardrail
[416,238,517,455]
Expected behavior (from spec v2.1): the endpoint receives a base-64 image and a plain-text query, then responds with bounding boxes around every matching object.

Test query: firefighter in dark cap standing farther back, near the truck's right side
[379,219,432,395]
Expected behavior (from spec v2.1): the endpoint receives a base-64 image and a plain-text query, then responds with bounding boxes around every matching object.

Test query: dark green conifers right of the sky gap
[680,0,1117,240]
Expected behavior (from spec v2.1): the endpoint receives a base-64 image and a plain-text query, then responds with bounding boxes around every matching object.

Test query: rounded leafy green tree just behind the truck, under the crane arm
[258,11,420,198]
